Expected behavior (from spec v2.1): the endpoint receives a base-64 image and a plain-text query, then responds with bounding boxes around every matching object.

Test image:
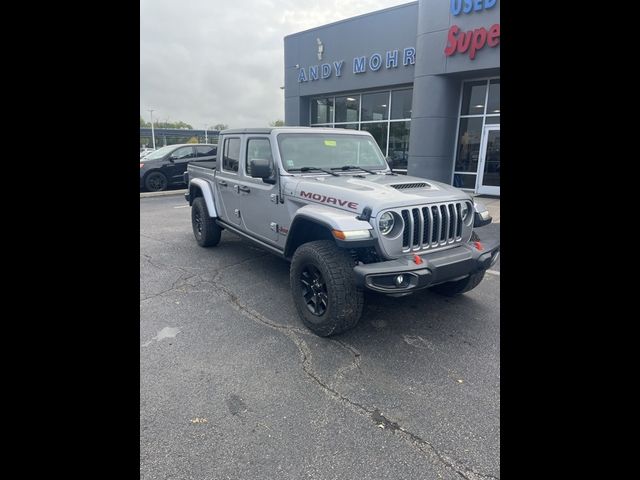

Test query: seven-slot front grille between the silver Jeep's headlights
[398,202,462,252]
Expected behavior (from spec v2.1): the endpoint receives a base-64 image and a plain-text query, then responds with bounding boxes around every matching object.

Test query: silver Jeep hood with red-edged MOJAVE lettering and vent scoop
[285,173,471,216]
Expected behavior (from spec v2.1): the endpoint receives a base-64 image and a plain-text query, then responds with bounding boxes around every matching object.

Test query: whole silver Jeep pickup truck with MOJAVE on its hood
[185,127,500,336]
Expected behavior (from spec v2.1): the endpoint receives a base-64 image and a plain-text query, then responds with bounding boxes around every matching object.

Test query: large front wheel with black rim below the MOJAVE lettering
[290,240,363,337]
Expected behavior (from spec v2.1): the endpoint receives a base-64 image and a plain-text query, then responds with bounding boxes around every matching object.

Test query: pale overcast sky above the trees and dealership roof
[140,0,409,129]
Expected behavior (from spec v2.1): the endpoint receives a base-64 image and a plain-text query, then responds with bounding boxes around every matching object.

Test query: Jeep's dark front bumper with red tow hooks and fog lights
[353,234,500,293]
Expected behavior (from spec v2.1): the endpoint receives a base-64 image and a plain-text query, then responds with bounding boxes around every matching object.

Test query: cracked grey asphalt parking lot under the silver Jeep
[140,195,500,480]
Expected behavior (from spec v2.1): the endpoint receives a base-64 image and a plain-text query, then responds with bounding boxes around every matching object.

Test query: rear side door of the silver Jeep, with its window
[216,135,243,226]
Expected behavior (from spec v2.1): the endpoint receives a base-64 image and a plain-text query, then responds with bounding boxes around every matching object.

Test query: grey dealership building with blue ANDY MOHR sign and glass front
[284,0,500,195]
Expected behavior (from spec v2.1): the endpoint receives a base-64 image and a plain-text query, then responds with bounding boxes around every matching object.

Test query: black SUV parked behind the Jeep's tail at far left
[140,143,218,192]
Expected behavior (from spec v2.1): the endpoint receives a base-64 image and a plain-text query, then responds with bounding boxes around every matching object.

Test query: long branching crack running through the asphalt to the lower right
[205,254,500,480]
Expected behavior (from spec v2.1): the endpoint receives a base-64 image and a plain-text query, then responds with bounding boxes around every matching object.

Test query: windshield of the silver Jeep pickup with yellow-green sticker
[278,133,387,171]
